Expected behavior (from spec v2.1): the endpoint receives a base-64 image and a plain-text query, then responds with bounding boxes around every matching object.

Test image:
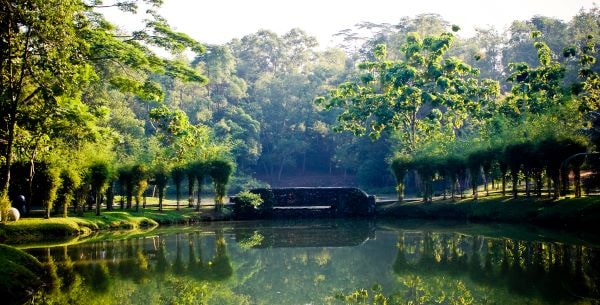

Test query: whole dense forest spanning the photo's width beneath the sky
[0,0,600,218]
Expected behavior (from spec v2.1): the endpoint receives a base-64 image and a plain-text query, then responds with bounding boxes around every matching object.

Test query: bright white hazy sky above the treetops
[106,0,598,45]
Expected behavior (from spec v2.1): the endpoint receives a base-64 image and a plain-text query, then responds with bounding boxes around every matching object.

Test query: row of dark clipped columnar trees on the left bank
[12,159,234,218]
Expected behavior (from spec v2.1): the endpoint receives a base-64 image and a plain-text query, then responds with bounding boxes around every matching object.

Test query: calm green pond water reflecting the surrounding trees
[27,220,600,305]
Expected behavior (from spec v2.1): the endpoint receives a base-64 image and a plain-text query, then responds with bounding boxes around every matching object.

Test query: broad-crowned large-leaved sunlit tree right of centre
[317,29,499,153]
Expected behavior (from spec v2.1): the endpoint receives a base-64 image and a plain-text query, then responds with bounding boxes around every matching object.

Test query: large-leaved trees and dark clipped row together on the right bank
[324,13,600,201]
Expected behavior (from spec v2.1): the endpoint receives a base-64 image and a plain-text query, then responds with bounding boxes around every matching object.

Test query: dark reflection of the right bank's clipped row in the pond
[392,231,600,304]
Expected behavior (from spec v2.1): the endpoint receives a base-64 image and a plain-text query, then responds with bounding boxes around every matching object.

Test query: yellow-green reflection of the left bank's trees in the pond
[31,231,236,304]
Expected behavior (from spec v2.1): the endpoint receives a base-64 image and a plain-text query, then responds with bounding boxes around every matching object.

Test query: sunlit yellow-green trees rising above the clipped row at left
[0,0,237,219]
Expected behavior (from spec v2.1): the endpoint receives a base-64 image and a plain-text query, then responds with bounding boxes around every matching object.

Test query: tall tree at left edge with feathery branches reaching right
[0,0,206,217]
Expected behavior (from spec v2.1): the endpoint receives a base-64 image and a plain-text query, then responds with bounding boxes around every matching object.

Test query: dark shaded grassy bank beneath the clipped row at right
[377,194,600,229]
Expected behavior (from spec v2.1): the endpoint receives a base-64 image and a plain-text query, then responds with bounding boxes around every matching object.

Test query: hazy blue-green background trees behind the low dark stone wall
[152,9,600,187]
